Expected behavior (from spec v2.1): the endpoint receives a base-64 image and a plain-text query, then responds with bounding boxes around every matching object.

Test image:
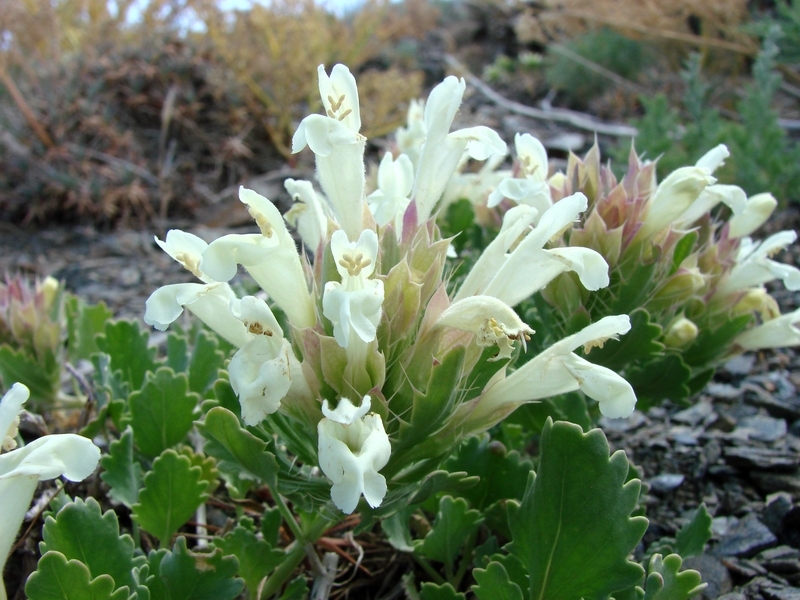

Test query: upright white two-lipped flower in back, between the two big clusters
[488,133,553,213]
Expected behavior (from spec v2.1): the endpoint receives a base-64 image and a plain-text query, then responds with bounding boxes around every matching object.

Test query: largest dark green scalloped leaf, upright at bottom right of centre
[509,420,647,600]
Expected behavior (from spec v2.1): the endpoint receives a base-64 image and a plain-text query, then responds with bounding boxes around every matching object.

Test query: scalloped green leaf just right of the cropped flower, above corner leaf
[39,497,141,588]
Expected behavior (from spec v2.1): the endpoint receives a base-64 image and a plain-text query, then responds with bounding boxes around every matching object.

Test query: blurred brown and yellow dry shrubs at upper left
[0,0,437,225]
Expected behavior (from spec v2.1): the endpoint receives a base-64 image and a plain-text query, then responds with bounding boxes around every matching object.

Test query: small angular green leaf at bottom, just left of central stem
[214,519,286,596]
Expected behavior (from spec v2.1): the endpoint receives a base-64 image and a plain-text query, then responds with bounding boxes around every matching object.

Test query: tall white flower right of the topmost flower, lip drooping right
[413,76,507,223]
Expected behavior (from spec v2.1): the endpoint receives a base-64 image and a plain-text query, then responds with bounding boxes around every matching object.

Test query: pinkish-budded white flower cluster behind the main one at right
[462,134,800,402]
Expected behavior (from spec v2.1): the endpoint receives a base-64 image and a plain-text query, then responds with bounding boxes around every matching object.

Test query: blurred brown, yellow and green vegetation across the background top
[0,0,800,227]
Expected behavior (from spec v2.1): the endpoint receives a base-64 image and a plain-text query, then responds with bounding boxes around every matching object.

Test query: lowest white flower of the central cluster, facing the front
[317,396,392,514]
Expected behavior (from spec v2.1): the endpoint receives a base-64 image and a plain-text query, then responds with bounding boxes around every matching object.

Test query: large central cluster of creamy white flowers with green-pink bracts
[145,65,636,513]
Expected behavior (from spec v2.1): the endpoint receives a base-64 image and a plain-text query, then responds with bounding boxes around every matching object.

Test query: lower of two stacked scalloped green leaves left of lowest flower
[132,450,208,546]
